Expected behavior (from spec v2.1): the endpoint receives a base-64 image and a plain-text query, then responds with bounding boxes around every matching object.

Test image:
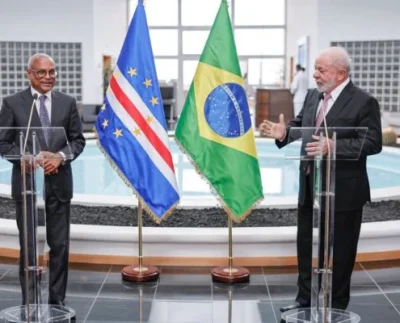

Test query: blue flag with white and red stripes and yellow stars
[95,1,179,223]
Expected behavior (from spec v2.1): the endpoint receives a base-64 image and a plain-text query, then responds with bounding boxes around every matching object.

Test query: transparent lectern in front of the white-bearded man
[282,127,368,323]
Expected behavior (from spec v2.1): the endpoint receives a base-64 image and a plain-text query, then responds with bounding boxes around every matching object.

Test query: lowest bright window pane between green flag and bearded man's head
[248,58,284,87]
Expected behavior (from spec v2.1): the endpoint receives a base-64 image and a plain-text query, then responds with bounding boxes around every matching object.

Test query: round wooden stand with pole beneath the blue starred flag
[121,198,160,282]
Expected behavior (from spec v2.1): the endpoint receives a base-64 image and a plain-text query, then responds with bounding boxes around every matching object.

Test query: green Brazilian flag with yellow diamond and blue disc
[175,0,263,222]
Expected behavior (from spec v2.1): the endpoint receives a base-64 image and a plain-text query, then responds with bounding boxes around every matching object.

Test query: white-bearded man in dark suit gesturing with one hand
[260,47,382,312]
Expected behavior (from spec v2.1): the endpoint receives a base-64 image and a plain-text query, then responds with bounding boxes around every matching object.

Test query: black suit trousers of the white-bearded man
[296,176,362,310]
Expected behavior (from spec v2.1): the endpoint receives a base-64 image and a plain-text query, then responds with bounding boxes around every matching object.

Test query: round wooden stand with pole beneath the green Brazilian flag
[211,215,250,283]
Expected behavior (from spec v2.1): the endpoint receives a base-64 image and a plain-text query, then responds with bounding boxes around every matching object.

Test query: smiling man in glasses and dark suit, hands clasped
[0,54,85,305]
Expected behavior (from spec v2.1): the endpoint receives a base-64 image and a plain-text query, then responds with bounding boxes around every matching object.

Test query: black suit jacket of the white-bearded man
[276,81,382,211]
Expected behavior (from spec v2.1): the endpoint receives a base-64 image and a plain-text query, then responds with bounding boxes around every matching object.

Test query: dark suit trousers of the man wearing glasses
[16,194,71,304]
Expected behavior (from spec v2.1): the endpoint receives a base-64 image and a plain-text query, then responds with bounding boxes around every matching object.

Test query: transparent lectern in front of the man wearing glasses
[0,127,75,323]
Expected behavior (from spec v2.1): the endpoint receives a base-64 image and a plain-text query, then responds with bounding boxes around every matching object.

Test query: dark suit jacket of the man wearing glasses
[0,88,85,202]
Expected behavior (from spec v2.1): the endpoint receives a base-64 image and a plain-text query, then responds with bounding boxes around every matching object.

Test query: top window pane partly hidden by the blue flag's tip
[129,0,178,26]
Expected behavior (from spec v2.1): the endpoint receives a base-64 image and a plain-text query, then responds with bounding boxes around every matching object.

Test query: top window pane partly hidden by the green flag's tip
[182,0,231,26]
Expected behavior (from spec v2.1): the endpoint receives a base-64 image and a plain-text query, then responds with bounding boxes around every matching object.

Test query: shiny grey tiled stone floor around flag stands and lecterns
[0,259,400,323]
